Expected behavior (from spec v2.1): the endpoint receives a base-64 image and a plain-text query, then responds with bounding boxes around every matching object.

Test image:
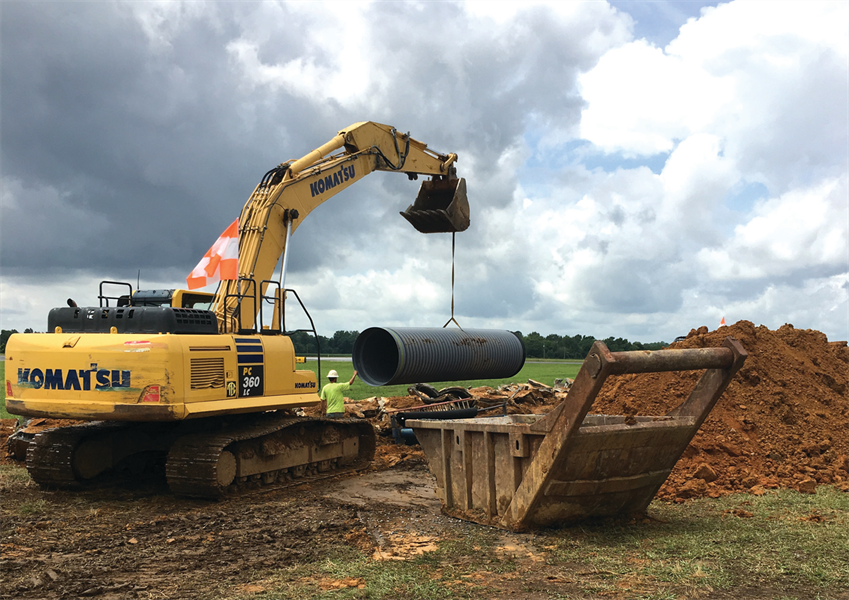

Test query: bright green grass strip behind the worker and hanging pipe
[302,360,581,400]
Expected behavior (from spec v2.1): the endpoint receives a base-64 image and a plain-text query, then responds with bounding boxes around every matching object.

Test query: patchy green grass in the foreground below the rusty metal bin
[224,486,849,600]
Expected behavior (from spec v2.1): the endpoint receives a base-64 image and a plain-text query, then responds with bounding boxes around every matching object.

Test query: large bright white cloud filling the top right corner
[581,2,849,179]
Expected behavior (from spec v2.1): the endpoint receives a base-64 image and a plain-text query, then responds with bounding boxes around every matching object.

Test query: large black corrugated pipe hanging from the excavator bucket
[353,327,525,386]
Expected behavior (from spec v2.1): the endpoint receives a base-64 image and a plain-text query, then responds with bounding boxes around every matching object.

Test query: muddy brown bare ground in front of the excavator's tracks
[0,445,564,600]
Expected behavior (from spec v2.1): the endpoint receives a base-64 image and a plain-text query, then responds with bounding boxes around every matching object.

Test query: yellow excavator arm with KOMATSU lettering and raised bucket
[212,122,469,332]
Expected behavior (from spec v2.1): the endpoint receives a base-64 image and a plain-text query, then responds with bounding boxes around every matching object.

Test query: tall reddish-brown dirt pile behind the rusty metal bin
[592,321,849,499]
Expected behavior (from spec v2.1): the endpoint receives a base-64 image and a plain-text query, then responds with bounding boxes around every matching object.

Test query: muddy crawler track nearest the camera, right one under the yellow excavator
[166,417,375,498]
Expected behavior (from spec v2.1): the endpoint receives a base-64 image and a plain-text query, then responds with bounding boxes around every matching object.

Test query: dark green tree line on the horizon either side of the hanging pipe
[290,331,669,359]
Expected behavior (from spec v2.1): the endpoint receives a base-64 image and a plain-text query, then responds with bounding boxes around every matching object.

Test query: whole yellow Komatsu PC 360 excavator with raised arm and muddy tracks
[6,122,469,497]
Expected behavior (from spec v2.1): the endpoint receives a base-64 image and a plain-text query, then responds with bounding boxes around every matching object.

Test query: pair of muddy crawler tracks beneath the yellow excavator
[22,413,375,498]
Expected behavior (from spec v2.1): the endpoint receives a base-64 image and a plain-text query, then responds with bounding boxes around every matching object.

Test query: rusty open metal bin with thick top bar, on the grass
[407,337,747,531]
